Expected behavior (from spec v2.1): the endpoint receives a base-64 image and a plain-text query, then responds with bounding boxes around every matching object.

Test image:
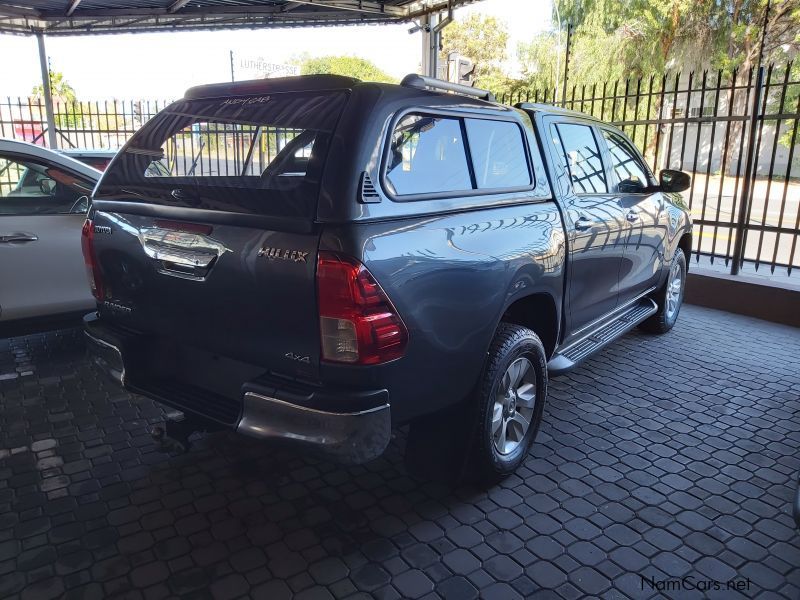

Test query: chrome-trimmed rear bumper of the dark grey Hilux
[84,313,391,464]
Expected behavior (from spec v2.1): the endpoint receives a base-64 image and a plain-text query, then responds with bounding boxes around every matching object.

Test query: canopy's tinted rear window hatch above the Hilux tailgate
[95,91,347,217]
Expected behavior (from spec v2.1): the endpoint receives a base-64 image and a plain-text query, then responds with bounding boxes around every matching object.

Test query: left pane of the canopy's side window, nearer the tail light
[386,115,472,195]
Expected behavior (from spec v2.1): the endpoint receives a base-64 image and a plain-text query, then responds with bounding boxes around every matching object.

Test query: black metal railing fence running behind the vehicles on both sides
[0,64,800,276]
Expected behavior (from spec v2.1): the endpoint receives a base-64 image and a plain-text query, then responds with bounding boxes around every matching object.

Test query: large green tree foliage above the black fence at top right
[555,0,800,83]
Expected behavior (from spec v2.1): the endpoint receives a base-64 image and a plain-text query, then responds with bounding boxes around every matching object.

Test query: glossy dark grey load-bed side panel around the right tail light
[320,198,565,422]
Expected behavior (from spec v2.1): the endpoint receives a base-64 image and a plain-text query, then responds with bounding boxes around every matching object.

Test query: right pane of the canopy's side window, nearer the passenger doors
[465,119,531,189]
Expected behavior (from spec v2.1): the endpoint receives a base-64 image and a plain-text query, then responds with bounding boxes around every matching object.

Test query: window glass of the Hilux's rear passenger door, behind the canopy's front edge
[553,123,608,194]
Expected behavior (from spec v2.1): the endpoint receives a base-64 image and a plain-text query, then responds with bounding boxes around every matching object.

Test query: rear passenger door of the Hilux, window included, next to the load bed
[544,117,626,333]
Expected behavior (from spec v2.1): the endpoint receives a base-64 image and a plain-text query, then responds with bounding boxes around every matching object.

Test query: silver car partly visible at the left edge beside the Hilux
[0,139,101,334]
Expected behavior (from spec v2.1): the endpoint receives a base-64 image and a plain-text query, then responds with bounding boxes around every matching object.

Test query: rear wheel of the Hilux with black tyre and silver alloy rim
[466,323,547,483]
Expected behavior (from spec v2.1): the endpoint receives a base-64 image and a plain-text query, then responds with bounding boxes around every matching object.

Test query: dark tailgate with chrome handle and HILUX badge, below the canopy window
[93,210,319,378]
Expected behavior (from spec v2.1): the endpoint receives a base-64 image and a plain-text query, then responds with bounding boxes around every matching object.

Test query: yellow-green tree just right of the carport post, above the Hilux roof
[441,13,509,91]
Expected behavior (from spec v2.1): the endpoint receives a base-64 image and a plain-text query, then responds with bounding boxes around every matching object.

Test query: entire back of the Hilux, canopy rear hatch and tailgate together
[92,92,346,378]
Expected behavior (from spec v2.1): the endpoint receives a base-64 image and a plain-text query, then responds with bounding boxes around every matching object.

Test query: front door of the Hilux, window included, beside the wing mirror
[600,127,667,304]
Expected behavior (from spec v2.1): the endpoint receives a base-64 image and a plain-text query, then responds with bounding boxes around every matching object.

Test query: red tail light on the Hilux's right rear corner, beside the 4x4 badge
[317,252,408,365]
